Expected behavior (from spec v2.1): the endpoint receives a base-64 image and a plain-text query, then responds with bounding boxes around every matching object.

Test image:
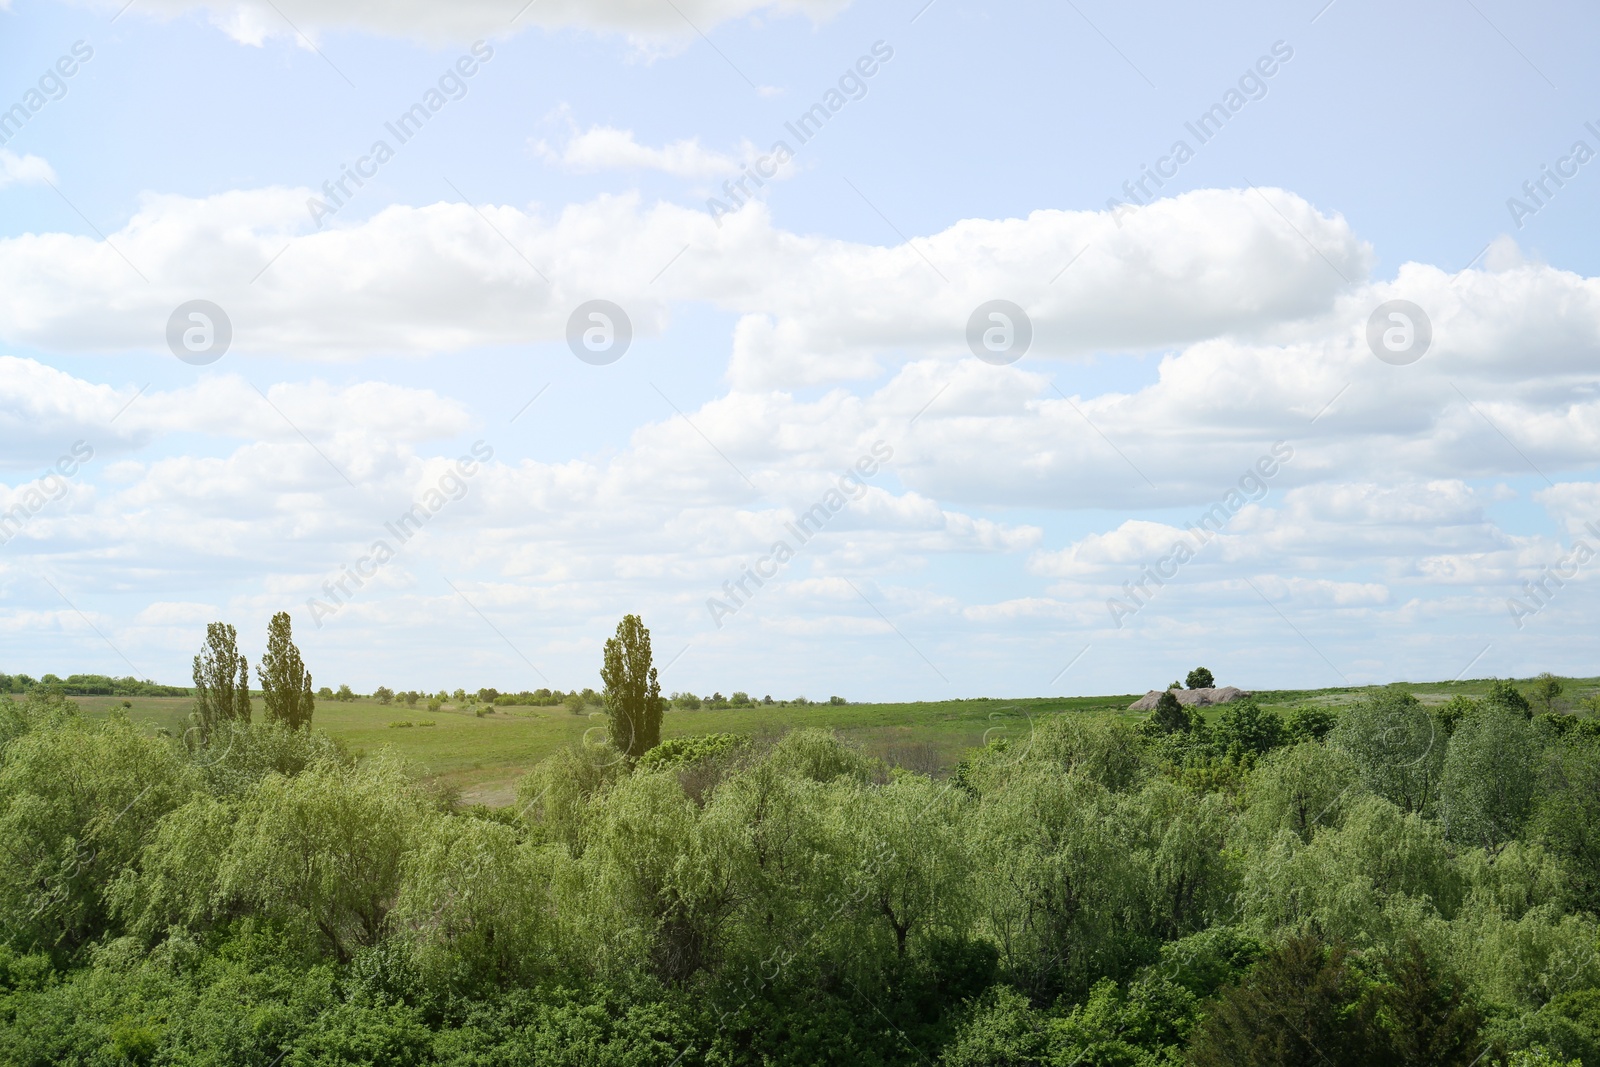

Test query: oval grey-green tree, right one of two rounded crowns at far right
[1440,702,1539,856]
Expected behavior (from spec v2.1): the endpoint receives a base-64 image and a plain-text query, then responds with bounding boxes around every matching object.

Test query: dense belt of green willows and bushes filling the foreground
[0,689,1600,1067]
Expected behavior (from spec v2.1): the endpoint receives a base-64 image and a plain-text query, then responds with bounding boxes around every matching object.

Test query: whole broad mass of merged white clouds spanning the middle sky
[0,182,1600,685]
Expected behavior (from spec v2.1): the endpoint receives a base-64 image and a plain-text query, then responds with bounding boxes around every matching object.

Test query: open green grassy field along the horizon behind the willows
[37,678,1600,805]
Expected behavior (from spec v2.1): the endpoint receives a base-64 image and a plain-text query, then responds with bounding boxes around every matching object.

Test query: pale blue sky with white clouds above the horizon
[0,0,1600,701]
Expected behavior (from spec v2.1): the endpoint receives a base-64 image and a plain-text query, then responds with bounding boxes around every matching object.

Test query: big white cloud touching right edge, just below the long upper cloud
[851,252,1600,509]
